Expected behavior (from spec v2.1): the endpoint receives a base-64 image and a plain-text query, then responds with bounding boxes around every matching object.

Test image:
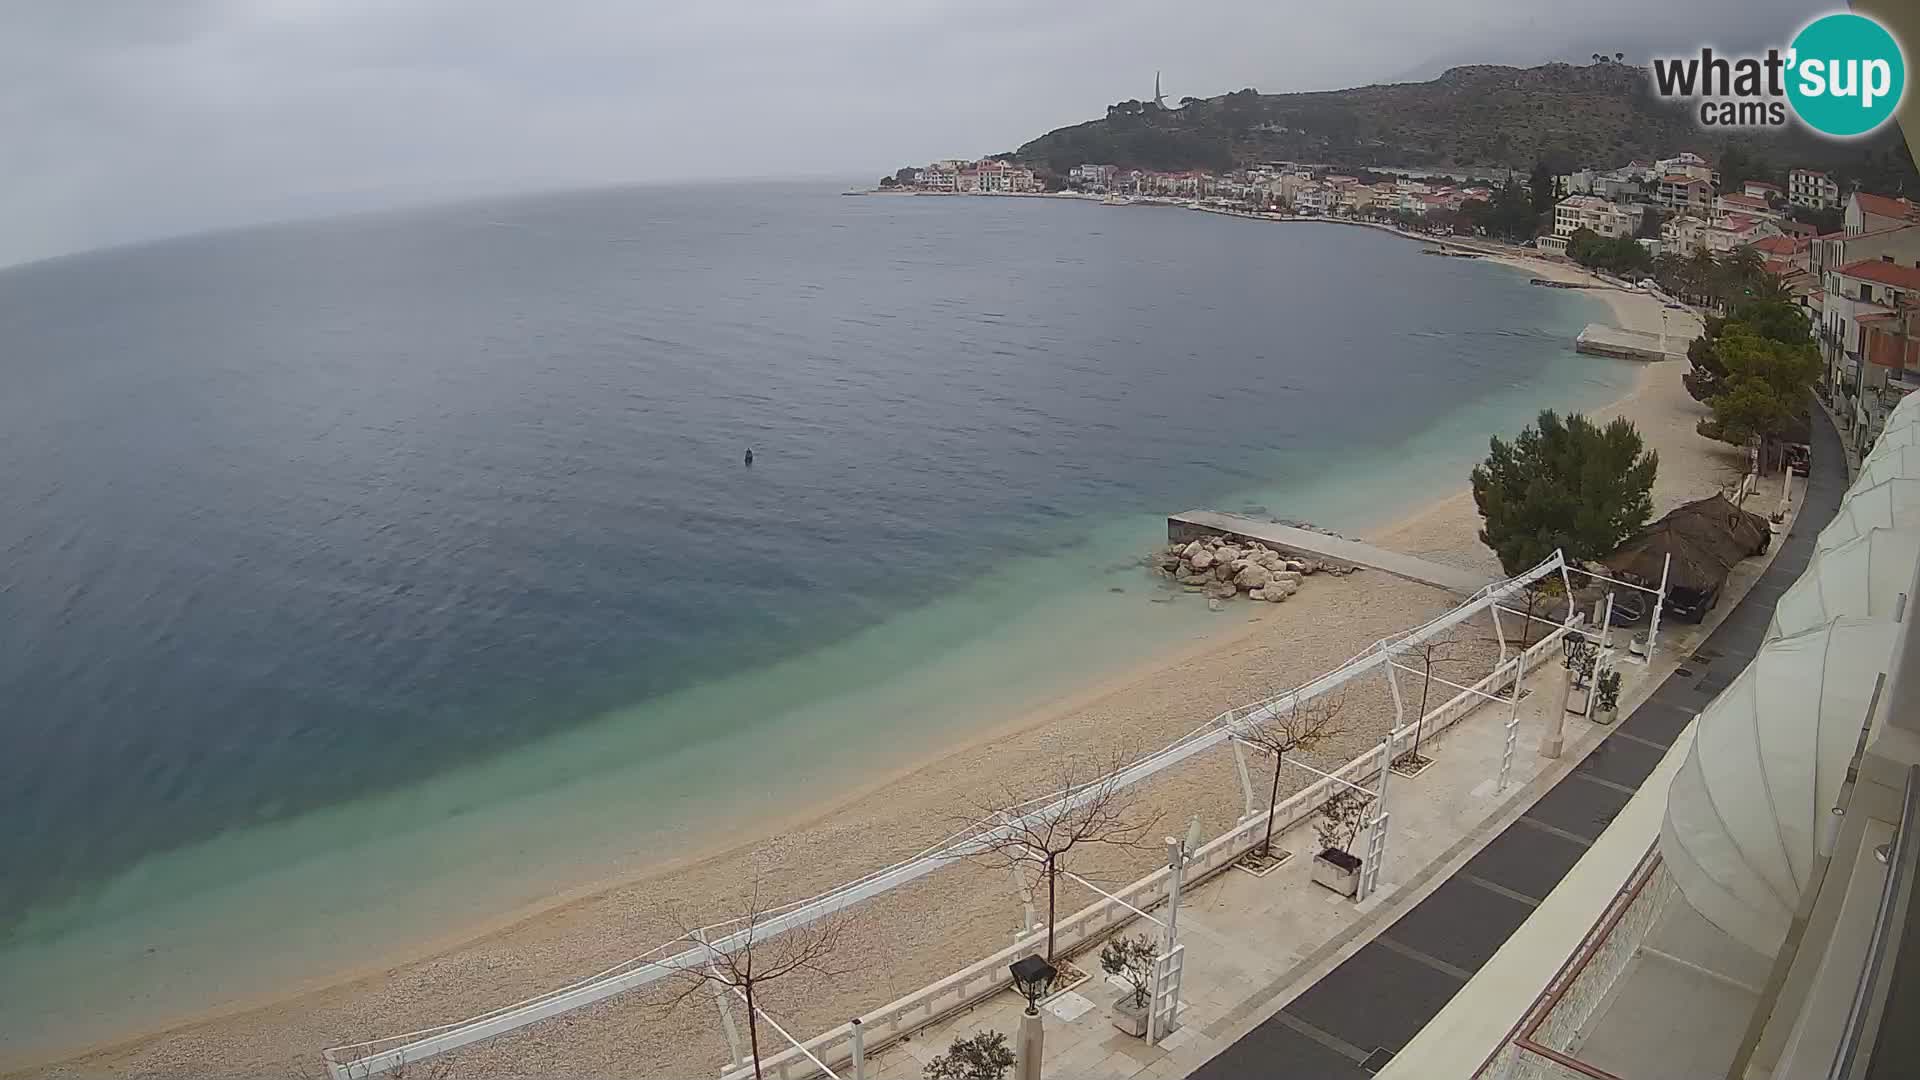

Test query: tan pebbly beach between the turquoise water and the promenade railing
[13,242,1741,1078]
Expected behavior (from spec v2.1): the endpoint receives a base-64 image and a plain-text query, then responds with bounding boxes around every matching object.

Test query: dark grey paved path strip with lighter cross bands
[1192,401,1847,1080]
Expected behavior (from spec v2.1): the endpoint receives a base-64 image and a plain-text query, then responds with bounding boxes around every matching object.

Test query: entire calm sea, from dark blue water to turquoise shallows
[0,186,1632,1049]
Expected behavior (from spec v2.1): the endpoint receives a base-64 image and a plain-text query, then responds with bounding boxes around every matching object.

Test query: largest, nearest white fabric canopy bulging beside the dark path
[1661,619,1895,955]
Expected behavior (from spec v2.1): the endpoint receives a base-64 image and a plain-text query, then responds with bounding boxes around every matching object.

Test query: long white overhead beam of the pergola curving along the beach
[321,552,1582,1080]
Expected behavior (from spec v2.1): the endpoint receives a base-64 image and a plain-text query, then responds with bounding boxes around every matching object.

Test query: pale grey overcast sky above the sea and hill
[0,0,1837,263]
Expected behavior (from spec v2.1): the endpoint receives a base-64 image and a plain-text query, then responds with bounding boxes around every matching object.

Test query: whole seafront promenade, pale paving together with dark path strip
[868,405,1845,1080]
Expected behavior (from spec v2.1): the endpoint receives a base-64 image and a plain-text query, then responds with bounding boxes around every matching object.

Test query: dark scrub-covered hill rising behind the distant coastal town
[1016,61,1912,186]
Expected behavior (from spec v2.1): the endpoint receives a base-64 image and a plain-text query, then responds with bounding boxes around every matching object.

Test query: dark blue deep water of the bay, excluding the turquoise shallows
[0,186,1628,1045]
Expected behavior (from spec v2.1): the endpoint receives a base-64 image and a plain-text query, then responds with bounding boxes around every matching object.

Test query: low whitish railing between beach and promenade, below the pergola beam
[722,628,1567,1080]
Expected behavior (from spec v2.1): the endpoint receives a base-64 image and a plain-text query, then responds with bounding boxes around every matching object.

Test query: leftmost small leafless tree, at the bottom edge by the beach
[666,876,852,1078]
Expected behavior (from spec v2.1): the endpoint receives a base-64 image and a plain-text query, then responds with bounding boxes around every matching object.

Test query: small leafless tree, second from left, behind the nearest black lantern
[968,753,1160,963]
